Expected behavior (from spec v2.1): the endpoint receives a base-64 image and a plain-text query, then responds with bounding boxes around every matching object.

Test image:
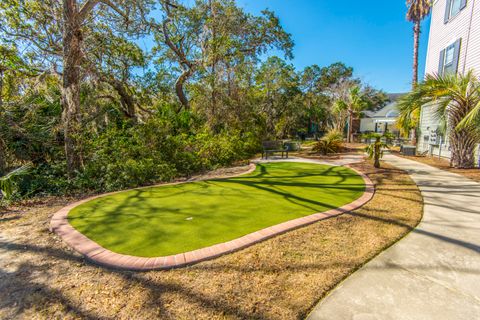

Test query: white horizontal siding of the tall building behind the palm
[418,0,480,158]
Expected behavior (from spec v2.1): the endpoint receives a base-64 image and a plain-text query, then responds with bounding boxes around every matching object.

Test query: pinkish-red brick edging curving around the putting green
[50,160,375,271]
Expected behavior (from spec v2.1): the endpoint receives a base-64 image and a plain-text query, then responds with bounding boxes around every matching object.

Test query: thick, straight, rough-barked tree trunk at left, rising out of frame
[62,0,83,176]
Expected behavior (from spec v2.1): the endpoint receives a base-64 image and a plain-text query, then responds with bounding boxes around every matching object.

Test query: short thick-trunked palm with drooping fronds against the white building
[399,71,480,168]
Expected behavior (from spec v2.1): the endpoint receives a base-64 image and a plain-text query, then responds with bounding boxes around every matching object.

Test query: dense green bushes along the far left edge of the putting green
[13,105,260,197]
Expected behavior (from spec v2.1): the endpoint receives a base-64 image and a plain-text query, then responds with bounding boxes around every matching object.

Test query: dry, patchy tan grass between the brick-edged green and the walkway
[0,163,422,319]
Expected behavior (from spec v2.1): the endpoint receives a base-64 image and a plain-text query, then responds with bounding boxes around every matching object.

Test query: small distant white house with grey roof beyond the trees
[360,102,399,135]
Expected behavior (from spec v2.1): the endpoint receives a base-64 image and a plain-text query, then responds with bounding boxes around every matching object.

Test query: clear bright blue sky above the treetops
[237,0,430,92]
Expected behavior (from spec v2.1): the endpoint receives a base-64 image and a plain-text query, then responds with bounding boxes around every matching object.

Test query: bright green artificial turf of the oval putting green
[68,162,365,257]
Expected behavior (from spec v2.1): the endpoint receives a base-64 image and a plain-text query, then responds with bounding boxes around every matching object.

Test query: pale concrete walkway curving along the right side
[308,155,480,320]
